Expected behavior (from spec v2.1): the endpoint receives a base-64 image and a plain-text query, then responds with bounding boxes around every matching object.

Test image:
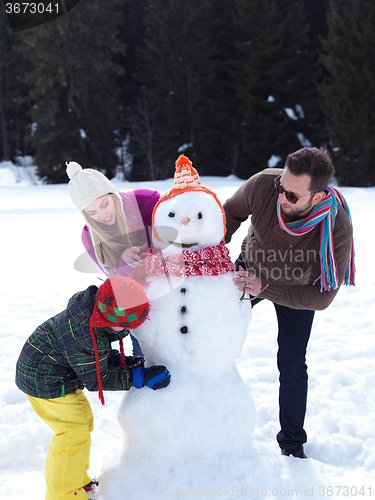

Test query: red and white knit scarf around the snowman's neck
[132,240,234,281]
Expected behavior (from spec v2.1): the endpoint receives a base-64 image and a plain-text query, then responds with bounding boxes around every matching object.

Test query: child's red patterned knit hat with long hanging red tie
[90,276,150,404]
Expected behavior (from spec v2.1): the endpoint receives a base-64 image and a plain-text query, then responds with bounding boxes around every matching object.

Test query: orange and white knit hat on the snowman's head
[152,155,226,240]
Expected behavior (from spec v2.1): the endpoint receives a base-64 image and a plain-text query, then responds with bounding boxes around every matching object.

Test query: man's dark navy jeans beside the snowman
[235,256,315,450]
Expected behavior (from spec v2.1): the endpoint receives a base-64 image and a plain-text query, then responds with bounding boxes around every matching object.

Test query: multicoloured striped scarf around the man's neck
[277,186,355,291]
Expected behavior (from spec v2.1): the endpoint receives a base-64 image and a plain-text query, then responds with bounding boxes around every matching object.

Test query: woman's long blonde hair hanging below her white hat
[82,193,132,276]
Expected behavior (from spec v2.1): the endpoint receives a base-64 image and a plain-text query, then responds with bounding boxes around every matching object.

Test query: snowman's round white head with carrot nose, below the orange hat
[154,191,225,254]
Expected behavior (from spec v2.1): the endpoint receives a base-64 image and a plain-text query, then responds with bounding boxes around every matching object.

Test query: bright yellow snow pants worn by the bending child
[27,389,94,500]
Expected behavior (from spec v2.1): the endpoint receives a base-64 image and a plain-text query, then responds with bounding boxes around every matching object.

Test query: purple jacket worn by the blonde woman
[82,189,160,276]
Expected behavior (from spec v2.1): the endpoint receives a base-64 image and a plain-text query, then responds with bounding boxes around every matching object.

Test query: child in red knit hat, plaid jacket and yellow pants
[16,276,170,500]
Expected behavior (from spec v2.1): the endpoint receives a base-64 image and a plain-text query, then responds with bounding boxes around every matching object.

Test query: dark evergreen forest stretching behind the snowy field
[0,0,375,186]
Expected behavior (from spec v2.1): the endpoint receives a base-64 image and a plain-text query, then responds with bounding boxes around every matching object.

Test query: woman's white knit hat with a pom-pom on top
[66,161,121,212]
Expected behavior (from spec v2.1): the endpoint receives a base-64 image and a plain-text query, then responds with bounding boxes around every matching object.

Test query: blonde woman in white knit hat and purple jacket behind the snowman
[66,162,160,355]
